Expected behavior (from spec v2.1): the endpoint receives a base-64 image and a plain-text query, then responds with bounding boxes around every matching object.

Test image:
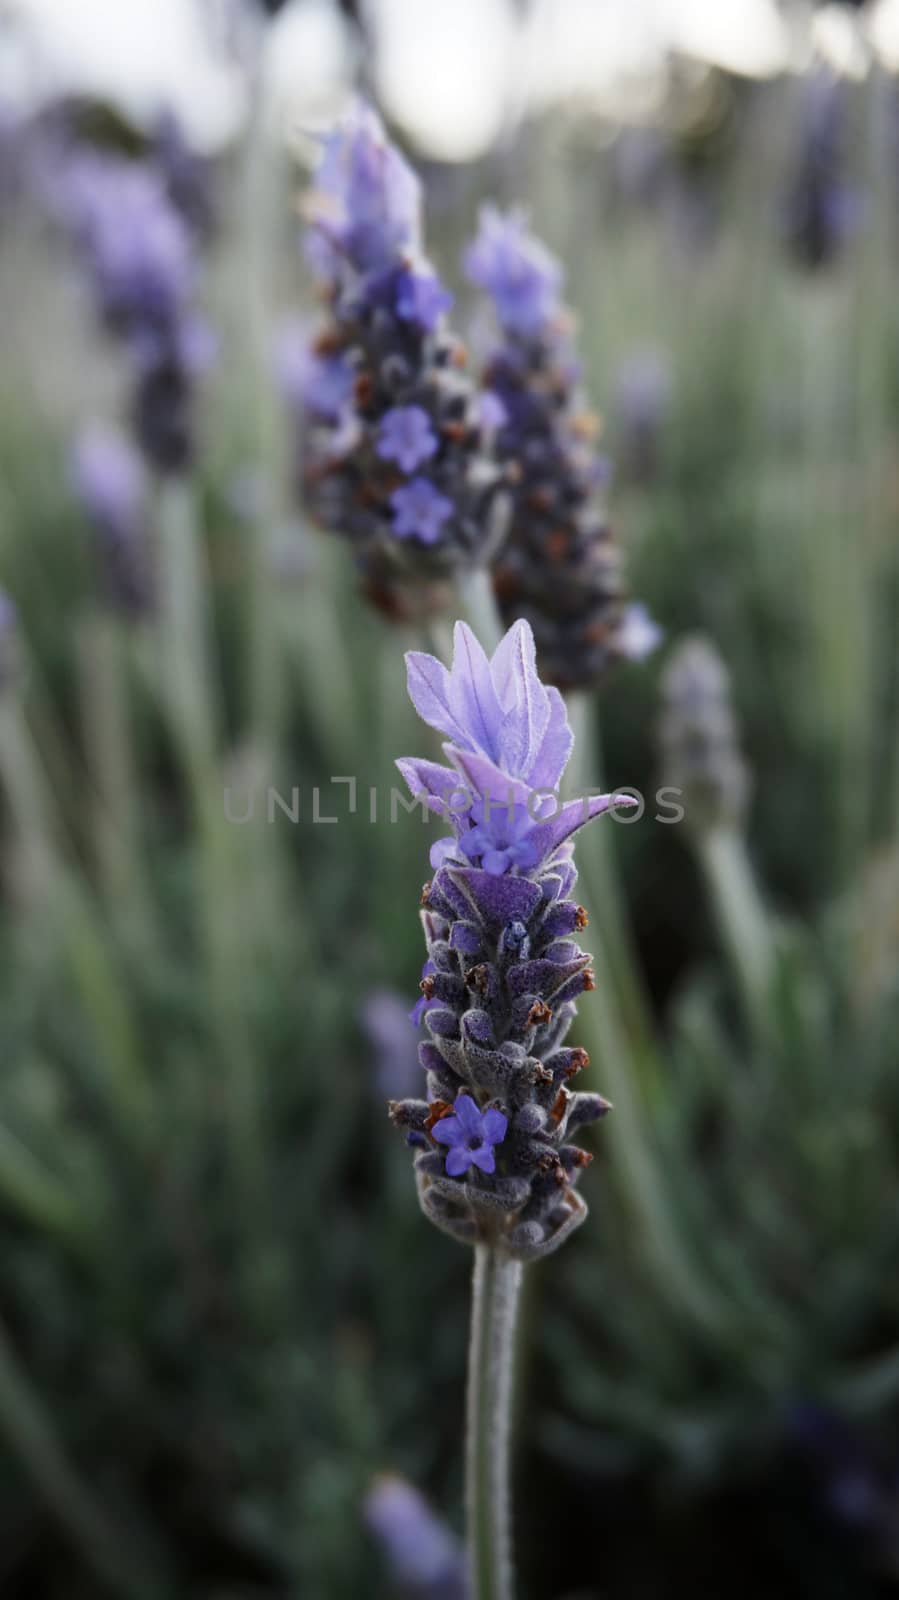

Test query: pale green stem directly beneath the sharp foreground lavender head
[465,1245,521,1600]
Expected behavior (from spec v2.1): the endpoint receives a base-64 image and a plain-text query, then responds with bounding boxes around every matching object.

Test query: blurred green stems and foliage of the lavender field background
[0,8,899,1600]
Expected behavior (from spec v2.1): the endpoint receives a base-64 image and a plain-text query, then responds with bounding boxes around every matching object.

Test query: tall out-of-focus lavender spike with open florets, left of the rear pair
[298,106,502,604]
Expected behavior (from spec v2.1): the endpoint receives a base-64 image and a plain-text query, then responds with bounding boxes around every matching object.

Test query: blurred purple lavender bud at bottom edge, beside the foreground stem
[365,1474,469,1600]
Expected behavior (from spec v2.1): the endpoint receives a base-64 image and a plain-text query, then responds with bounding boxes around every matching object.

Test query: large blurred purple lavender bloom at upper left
[56,154,213,472]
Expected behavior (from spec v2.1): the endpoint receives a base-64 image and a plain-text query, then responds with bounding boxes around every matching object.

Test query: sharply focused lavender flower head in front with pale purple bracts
[390,621,627,1261]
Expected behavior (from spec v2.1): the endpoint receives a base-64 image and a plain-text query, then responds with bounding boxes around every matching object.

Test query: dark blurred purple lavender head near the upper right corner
[784,67,864,270]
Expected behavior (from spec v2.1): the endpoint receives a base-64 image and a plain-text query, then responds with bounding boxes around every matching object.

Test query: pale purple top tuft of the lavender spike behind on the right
[465,206,563,334]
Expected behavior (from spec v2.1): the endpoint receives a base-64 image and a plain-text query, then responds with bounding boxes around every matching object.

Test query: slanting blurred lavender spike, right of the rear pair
[465,208,655,688]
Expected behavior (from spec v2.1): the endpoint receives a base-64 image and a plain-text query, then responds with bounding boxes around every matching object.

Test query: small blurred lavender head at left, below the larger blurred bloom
[72,422,154,618]
